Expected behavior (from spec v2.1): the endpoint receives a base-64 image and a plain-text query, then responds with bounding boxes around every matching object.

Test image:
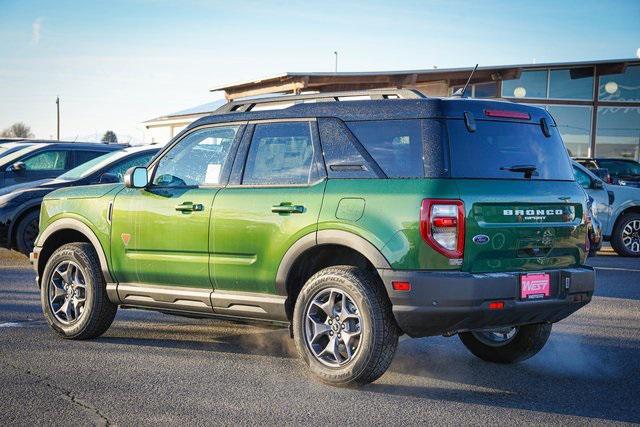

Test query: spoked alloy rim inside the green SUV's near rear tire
[304,288,363,368]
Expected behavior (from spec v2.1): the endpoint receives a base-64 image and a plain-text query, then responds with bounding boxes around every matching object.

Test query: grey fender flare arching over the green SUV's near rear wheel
[276,230,391,296]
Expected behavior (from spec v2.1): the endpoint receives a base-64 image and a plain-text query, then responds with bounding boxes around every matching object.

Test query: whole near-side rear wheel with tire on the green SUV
[293,266,399,386]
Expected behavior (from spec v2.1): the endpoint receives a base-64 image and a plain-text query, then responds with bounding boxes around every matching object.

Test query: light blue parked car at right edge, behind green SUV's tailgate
[573,162,640,257]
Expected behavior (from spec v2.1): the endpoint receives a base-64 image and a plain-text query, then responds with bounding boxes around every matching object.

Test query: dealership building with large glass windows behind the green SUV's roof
[144,59,640,160]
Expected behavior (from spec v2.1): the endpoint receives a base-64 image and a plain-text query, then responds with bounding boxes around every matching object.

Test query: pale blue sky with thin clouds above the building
[0,0,640,143]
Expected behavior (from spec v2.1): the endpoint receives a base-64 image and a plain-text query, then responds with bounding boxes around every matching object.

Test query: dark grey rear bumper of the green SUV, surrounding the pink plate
[378,267,595,337]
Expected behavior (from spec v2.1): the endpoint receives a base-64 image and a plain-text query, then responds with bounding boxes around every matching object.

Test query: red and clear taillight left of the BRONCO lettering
[420,199,464,258]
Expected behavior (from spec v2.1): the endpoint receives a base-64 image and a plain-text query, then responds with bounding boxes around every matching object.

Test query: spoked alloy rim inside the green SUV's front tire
[48,261,87,325]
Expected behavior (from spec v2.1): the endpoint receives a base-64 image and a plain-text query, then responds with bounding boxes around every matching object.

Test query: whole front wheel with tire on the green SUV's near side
[40,243,118,340]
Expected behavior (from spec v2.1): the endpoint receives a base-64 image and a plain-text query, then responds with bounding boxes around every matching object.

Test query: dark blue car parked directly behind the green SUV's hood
[0,146,159,255]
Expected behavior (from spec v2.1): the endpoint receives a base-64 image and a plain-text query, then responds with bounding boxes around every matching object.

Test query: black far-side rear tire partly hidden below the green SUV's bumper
[458,323,551,363]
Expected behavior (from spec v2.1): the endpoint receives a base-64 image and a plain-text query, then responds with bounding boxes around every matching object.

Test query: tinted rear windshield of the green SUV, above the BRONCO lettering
[447,120,575,181]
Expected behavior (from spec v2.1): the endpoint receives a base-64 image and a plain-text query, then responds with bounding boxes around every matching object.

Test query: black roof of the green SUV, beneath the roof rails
[187,97,555,129]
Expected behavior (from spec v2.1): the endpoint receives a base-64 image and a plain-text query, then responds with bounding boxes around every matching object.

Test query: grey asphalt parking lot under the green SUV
[0,249,640,425]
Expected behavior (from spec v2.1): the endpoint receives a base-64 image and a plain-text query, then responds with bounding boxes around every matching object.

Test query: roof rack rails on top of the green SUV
[213,89,426,114]
